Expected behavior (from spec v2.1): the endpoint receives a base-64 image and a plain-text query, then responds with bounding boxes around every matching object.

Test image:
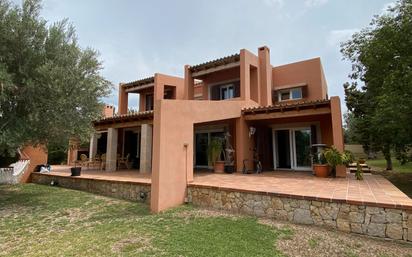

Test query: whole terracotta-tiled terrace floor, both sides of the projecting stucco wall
[30,166,412,210]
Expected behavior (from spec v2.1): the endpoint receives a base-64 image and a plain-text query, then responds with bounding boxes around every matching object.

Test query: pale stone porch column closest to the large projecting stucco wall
[140,124,153,173]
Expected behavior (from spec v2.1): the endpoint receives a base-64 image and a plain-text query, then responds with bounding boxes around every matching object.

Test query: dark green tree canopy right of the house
[341,0,412,169]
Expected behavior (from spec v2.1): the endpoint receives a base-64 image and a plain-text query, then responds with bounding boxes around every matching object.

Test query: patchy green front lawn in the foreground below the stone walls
[0,184,291,256]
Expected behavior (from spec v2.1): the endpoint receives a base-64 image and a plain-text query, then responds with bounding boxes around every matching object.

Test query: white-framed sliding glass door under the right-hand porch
[273,128,311,170]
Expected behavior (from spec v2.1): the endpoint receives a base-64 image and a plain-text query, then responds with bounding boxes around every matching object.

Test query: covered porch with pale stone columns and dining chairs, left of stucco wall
[86,111,153,173]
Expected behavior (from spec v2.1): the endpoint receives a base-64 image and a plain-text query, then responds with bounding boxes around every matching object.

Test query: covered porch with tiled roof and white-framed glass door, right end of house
[242,99,346,177]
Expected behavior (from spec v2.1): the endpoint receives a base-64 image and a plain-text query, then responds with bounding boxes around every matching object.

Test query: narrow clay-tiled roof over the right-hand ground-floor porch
[242,99,330,115]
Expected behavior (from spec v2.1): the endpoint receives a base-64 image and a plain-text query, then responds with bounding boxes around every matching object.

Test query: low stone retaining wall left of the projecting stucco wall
[31,173,150,204]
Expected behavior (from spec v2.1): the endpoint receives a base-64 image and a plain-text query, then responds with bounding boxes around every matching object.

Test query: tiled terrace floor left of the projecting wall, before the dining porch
[44,165,152,184]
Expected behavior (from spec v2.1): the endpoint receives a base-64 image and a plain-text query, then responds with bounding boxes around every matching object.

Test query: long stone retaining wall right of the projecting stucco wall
[188,186,412,241]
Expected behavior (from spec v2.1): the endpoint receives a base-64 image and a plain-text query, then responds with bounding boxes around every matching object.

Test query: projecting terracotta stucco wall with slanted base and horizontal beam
[151,100,256,212]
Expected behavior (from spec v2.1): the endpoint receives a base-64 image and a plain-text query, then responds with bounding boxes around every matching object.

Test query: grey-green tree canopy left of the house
[0,0,111,162]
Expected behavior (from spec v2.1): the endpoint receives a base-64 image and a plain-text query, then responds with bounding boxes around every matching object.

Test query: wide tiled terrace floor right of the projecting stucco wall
[190,171,412,209]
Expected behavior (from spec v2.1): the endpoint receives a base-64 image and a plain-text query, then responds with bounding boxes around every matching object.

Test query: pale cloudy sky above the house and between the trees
[14,0,393,111]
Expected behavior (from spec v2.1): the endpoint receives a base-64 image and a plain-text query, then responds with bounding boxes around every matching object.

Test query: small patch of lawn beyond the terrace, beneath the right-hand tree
[366,159,412,197]
